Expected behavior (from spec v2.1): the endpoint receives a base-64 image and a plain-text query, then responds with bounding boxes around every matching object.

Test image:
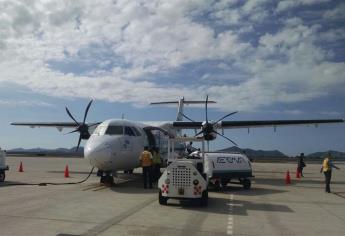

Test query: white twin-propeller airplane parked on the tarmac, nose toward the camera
[11,96,344,185]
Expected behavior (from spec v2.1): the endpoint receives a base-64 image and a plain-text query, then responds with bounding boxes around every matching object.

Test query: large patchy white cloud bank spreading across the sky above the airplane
[0,0,345,113]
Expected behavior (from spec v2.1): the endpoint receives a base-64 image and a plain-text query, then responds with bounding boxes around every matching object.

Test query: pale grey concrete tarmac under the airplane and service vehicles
[0,157,345,236]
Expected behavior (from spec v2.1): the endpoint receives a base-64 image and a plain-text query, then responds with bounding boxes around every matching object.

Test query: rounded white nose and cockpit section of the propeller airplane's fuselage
[84,120,148,171]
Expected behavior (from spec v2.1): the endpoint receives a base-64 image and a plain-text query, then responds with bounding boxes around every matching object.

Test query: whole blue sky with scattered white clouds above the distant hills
[0,0,345,155]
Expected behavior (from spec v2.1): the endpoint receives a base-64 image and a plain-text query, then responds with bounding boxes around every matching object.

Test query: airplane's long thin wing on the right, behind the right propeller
[173,119,344,129]
